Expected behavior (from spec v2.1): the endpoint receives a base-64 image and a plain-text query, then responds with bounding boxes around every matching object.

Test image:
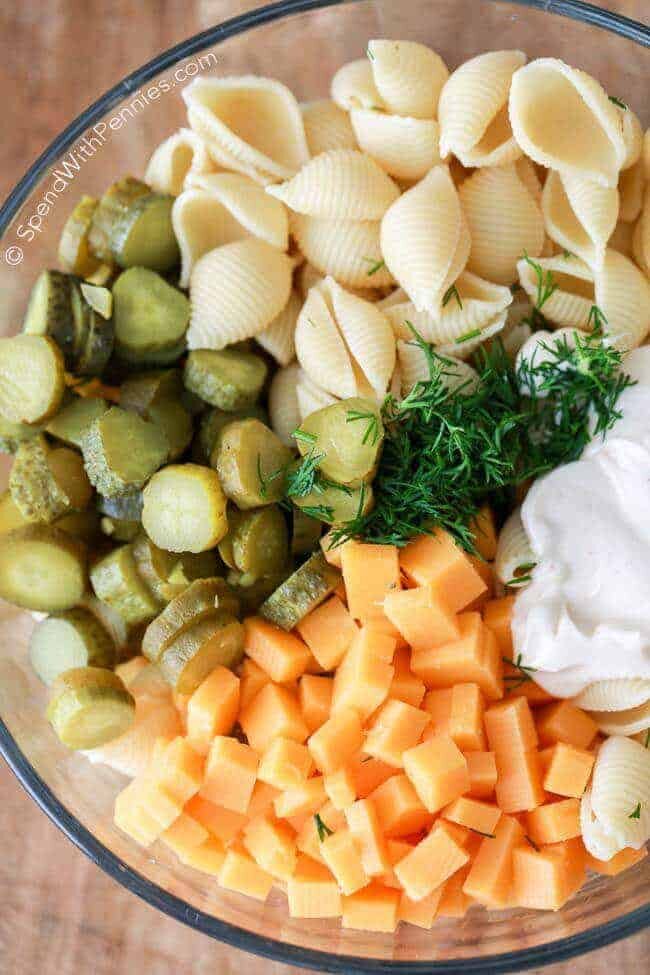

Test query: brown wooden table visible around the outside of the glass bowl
[0,0,650,975]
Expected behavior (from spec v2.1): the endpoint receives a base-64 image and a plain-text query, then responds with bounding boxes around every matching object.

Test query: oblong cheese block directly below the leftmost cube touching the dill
[332,628,395,721]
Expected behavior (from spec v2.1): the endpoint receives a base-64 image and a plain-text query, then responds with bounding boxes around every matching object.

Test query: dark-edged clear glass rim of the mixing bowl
[0,0,650,975]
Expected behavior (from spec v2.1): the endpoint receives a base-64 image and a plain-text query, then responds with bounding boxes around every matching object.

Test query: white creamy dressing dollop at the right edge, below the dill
[513,347,650,697]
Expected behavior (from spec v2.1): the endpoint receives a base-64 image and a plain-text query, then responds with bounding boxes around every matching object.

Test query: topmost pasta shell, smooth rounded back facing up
[368,40,449,119]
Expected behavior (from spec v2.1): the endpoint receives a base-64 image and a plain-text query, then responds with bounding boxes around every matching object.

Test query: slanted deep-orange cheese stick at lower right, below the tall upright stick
[463,815,524,907]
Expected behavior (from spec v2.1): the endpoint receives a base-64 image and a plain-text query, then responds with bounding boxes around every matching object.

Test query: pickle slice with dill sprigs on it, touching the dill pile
[296,396,384,485]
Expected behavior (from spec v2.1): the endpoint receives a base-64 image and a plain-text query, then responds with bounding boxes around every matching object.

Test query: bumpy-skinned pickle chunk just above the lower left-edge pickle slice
[9,436,92,523]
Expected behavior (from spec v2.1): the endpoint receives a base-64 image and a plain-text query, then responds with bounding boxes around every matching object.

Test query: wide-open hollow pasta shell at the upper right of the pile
[510,58,627,186]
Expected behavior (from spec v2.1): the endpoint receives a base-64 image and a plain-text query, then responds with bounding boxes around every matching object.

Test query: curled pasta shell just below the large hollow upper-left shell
[172,173,289,288]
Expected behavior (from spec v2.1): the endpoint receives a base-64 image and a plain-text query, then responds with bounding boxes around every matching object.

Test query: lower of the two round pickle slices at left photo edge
[0,525,87,613]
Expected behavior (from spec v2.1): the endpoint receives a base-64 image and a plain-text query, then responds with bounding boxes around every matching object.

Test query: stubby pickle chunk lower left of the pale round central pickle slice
[90,545,160,626]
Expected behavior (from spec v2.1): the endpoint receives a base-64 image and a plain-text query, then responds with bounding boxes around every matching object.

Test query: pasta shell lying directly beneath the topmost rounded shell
[350,108,440,181]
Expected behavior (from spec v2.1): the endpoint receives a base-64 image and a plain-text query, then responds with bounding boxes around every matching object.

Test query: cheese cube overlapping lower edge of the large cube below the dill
[384,583,460,650]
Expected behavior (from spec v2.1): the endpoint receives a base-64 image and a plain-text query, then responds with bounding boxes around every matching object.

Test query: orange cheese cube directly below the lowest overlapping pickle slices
[186,667,239,755]
